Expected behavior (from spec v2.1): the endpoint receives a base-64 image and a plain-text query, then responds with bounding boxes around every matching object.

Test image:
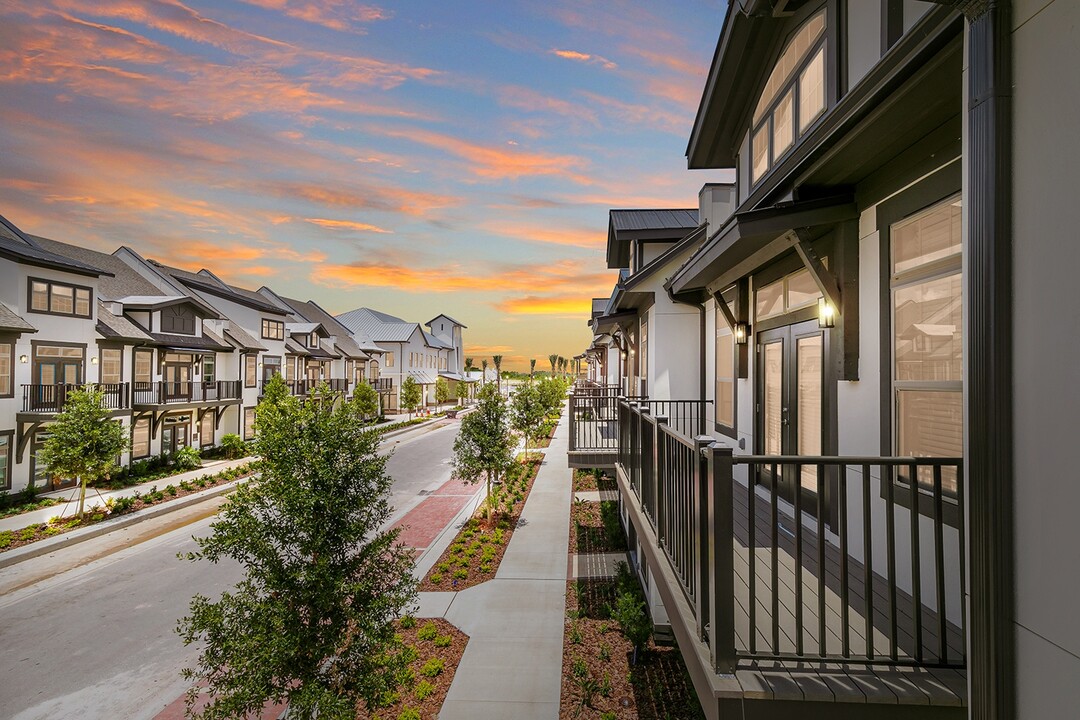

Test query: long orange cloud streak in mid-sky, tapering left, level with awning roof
[376,128,592,185]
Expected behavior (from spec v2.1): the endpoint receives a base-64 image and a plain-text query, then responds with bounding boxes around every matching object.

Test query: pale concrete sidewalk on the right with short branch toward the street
[417,405,571,720]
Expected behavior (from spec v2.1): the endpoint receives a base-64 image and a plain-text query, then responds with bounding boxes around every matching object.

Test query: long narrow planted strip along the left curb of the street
[0,462,256,553]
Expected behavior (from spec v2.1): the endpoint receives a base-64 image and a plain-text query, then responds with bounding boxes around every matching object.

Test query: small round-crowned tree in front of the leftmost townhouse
[38,385,127,520]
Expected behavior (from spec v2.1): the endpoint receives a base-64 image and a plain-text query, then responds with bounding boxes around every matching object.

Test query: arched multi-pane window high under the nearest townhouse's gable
[751,10,826,184]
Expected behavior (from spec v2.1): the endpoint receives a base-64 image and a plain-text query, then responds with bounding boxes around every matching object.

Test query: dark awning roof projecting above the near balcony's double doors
[664,195,859,295]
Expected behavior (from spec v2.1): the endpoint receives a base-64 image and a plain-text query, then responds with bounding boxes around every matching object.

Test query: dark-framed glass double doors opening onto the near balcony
[757,321,827,513]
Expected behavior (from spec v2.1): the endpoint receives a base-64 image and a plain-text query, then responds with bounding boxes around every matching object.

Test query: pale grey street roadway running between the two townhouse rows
[0,423,457,720]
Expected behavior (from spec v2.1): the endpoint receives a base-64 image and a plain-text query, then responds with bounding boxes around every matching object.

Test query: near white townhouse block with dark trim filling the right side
[570,0,1080,718]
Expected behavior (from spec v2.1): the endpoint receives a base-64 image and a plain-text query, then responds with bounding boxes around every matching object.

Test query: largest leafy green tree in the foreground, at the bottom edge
[177,378,416,720]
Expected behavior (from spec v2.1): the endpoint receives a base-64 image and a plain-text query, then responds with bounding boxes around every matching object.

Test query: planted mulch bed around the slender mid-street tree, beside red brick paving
[420,452,543,592]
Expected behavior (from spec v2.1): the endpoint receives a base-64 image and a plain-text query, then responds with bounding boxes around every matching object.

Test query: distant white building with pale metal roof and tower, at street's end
[337,308,468,412]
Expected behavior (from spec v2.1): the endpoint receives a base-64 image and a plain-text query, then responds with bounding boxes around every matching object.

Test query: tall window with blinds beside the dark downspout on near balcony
[889,198,963,493]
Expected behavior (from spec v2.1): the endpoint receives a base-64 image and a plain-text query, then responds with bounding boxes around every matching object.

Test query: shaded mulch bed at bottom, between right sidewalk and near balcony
[558,580,704,720]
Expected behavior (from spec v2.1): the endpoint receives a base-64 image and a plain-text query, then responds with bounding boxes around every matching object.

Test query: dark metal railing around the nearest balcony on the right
[618,403,966,673]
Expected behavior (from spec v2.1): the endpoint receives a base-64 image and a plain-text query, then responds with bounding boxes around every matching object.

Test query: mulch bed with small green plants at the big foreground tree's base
[356,617,469,720]
